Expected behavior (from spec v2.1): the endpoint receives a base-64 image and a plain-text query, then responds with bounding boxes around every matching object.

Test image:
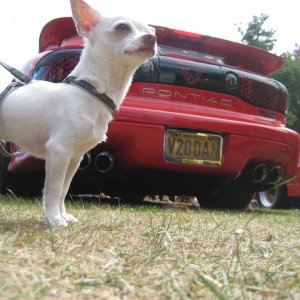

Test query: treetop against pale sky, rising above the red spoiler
[238,13,277,51]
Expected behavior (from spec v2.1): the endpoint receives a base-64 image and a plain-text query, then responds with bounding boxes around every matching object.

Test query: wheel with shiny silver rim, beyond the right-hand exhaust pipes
[257,185,291,209]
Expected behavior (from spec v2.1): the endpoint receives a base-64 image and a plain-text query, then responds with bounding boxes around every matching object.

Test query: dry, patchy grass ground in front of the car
[0,197,300,299]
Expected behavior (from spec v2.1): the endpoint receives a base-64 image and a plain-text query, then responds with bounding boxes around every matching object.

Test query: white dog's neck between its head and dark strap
[70,46,136,107]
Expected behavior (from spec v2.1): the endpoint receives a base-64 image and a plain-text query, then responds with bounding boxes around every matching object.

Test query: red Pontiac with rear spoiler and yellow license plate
[0,18,299,208]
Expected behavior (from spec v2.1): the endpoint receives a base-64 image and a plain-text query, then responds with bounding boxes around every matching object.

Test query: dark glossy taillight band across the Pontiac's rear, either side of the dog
[33,47,288,115]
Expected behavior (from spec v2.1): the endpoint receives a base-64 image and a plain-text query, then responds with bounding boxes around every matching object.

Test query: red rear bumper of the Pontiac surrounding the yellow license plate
[9,102,299,190]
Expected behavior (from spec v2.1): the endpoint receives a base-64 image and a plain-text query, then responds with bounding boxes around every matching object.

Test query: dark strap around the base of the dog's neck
[63,76,117,112]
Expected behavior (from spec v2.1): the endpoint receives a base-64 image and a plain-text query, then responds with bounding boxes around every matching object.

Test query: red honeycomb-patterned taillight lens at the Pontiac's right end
[240,74,288,114]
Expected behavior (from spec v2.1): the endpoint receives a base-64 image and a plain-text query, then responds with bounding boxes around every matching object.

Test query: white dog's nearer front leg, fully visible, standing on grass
[43,142,71,227]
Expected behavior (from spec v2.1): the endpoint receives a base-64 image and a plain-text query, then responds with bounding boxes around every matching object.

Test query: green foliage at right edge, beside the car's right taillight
[273,51,300,132]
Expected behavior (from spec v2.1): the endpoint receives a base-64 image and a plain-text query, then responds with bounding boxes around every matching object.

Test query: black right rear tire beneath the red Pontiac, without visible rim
[198,186,253,210]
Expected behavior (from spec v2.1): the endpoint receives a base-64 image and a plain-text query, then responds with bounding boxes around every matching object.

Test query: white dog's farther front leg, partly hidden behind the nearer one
[59,155,83,223]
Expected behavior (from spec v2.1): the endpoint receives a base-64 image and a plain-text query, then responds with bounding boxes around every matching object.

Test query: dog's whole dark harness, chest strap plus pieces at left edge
[0,60,117,157]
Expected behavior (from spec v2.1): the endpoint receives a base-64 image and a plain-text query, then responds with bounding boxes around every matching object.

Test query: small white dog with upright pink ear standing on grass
[0,0,157,227]
